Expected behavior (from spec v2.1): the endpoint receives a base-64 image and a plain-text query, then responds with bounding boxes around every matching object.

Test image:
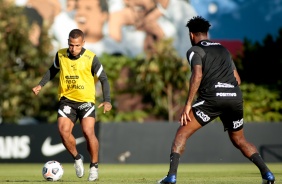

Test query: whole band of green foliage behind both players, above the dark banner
[0,0,282,123]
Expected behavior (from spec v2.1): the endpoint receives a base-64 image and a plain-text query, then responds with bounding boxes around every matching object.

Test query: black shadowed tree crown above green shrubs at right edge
[236,29,282,89]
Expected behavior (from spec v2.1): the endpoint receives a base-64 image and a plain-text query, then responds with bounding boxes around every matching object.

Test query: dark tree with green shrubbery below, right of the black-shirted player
[235,29,282,122]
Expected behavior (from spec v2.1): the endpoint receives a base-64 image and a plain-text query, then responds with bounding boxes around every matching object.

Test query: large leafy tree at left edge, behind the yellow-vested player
[0,0,54,122]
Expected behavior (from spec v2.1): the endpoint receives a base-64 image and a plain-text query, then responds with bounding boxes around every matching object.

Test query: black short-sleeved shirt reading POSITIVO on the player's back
[187,40,242,100]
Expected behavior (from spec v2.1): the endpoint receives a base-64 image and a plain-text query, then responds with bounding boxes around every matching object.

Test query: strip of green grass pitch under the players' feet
[0,163,282,184]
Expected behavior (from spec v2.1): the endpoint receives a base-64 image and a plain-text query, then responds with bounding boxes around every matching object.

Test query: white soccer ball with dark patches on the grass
[42,160,64,181]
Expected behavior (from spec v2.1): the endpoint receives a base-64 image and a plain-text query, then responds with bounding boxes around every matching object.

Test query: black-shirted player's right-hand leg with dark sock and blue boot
[228,129,275,184]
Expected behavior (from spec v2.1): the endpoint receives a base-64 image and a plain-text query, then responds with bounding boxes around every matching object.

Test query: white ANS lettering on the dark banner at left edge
[0,135,30,159]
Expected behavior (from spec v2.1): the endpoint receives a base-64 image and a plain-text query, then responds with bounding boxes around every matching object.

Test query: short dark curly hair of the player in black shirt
[186,16,211,33]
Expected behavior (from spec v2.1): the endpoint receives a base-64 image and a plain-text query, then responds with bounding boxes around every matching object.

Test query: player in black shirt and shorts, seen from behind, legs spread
[158,16,275,184]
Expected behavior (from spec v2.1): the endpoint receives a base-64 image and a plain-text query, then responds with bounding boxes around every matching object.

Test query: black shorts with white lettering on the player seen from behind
[192,99,244,131]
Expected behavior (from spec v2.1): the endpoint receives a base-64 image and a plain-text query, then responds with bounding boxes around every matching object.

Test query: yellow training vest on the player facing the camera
[58,49,95,103]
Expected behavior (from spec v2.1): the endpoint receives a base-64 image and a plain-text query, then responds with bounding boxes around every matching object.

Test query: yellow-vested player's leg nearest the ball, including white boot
[58,117,84,178]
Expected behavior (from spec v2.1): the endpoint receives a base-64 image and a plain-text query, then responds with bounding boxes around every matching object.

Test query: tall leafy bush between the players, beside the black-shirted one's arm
[135,40,189,122]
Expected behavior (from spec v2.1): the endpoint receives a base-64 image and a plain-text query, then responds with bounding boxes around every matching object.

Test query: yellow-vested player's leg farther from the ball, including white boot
[81,117,99,181]
